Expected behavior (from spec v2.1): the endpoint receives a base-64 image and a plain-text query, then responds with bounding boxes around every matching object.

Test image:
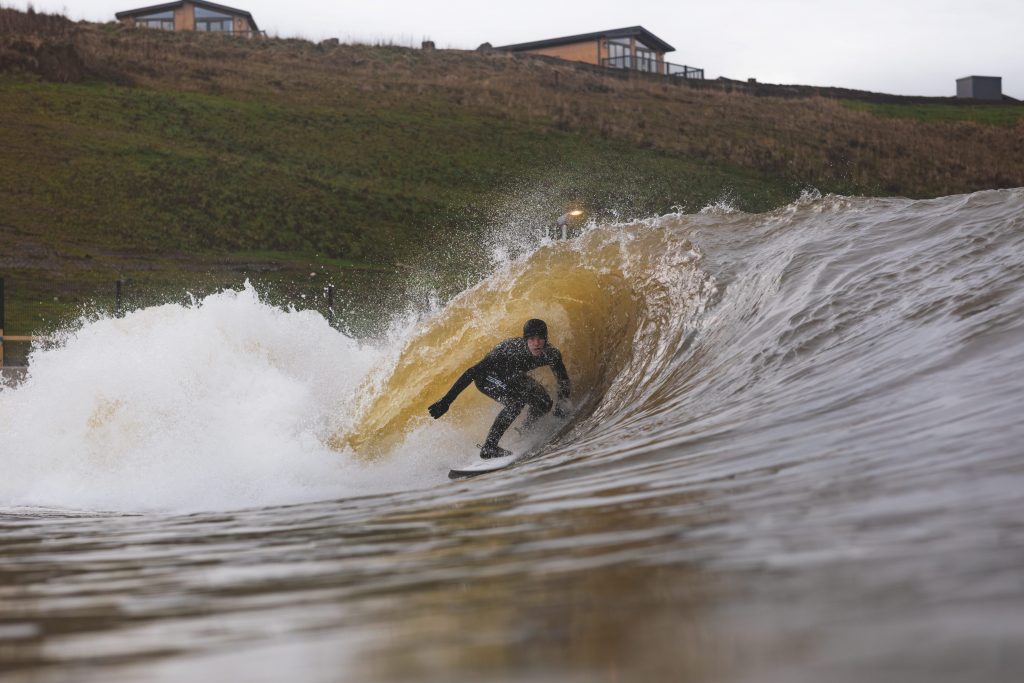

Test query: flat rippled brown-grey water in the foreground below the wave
[0,448,1024,681]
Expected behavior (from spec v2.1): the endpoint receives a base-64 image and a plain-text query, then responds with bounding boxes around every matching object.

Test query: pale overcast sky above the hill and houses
[9,0,1024,99]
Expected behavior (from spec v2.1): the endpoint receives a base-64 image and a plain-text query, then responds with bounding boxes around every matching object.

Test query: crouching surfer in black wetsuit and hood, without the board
[427,317,569,458]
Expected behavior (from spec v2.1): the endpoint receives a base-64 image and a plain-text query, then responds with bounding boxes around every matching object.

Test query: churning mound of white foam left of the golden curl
[0,287,444,511]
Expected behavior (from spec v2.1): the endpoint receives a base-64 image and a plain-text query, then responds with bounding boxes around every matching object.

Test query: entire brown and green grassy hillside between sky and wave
[0,9,1024,344]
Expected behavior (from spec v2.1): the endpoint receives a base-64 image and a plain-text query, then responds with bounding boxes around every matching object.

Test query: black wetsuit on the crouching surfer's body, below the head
[437,337,569,446]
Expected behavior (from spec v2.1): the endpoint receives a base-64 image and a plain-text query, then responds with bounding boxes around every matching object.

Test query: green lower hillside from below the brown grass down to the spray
[0,70,799,344]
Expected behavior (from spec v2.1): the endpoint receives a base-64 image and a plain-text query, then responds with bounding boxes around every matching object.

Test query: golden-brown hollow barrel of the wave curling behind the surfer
[330,234,640,459]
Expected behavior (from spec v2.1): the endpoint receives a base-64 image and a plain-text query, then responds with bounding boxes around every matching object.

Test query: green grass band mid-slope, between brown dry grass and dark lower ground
[0,77,791,262]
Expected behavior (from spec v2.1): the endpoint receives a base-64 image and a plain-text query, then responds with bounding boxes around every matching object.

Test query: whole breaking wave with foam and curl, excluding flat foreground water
[0,190,1024,510]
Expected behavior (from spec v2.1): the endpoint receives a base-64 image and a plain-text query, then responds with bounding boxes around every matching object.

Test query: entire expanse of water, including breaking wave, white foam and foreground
[0,189,1024,682]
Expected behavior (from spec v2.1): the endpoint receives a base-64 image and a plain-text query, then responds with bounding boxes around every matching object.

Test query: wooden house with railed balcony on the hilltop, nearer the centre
[495,26,703,79]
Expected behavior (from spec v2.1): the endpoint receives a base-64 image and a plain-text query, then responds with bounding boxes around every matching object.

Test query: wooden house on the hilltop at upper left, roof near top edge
[115,0,263,36]
